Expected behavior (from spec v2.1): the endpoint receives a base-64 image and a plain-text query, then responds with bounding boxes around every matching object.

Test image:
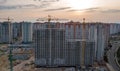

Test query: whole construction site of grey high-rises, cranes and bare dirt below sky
[0,16,120,71]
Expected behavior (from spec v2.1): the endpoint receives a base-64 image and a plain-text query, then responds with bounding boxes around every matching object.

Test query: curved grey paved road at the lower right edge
[107,43,120,71]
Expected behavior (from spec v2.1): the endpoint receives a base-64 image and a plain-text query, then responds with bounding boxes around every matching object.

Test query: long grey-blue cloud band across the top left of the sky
[0,0,59,10]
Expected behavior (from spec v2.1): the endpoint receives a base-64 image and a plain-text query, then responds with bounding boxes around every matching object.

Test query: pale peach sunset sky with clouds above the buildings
[0,0,120,23]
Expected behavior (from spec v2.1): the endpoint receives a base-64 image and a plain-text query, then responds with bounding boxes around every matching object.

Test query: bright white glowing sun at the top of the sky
[68,0,93,10]
